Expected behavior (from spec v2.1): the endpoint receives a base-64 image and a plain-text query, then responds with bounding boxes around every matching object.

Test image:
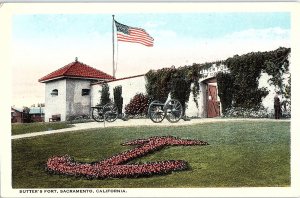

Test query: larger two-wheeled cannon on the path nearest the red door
[148,99,183,123]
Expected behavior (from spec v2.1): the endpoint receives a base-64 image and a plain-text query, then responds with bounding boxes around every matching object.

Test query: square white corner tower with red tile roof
[38,58,114,122]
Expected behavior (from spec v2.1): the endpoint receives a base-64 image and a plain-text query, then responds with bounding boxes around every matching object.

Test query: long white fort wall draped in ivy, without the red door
[91,47,291,117]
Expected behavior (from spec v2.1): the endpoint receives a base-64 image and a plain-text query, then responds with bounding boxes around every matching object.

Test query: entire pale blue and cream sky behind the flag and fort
[11,12,291,106]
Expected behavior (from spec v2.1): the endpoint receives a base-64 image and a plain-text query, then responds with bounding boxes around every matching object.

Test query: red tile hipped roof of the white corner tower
[39,61,114,82]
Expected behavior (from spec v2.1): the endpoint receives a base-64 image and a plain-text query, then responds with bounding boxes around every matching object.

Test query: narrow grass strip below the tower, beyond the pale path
[11,122,72,135]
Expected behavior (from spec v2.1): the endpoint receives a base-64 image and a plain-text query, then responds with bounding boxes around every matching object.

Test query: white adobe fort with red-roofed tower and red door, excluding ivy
[39,48,290,122]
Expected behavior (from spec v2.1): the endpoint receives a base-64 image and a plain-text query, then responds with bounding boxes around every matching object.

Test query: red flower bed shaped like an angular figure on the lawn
[46,136,208,179]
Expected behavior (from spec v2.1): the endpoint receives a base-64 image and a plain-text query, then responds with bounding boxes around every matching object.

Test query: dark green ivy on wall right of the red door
[217,47,291,109]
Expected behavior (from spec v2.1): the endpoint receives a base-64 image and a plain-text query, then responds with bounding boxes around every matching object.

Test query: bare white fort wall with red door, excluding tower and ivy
[91,48,291,118]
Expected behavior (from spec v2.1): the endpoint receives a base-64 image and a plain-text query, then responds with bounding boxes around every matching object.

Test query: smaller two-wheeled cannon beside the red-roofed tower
[91,103,118,122]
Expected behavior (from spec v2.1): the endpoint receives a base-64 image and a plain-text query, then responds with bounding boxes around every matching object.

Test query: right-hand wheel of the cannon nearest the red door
[164,99,183,123]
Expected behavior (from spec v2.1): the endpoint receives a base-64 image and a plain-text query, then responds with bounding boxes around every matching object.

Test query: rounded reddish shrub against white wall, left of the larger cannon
[125,93,150,116]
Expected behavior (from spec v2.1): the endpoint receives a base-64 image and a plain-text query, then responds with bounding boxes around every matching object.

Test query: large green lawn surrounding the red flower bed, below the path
[12,121,291,188]
